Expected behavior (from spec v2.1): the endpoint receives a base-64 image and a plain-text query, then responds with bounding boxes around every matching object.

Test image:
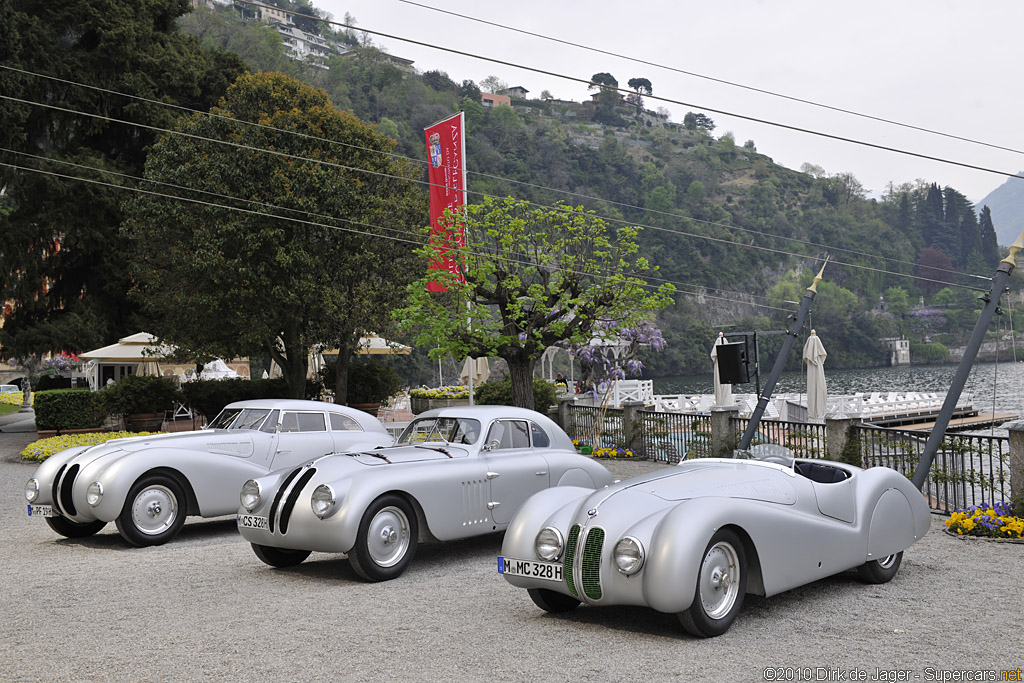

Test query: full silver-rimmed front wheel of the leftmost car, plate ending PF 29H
[117,474,187,547]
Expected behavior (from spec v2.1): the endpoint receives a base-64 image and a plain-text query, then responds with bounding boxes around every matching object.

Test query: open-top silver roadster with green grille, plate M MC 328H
[498,446,929,637]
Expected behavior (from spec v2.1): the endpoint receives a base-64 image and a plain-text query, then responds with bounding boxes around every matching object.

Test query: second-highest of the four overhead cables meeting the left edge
[0,95,983,291]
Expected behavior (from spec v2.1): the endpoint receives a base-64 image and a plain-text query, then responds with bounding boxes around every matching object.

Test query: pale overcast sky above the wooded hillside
[313,0,1024,201]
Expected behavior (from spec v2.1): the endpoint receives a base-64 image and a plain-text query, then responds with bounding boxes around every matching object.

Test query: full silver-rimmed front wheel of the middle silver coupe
[348,494,419,582]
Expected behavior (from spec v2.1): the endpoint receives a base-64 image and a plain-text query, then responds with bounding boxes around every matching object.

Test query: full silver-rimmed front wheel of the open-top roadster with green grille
[677,529,746,638]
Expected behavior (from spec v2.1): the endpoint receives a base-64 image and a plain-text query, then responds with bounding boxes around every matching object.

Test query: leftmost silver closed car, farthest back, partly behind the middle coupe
[25,399,394,546]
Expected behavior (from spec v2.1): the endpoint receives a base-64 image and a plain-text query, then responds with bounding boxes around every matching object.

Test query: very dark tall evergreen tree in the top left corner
[0,0,245,356]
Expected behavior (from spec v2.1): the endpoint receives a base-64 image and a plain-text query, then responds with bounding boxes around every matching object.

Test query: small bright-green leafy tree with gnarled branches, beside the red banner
[397,199,674,408]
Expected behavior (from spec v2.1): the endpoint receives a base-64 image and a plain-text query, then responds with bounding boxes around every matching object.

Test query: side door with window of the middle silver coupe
[481,420,550,524]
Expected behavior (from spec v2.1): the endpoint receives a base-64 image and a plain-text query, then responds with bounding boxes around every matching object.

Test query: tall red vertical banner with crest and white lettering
[423,112,466,292]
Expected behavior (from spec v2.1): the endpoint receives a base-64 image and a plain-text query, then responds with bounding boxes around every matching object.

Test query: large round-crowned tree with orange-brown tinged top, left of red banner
[125,74,427,402]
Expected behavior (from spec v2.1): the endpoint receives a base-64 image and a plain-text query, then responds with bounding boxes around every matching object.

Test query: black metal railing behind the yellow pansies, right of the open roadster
[854,425,1011,514]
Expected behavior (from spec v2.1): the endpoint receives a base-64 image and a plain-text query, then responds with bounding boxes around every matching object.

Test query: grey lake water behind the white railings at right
[654,361,1024,415]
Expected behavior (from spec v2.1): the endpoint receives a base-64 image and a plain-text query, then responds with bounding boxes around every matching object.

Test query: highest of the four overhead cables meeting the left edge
[0,65,989,281]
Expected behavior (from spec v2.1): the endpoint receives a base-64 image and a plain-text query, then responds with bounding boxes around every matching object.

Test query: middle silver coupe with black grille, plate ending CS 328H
[238,405,611,581]
